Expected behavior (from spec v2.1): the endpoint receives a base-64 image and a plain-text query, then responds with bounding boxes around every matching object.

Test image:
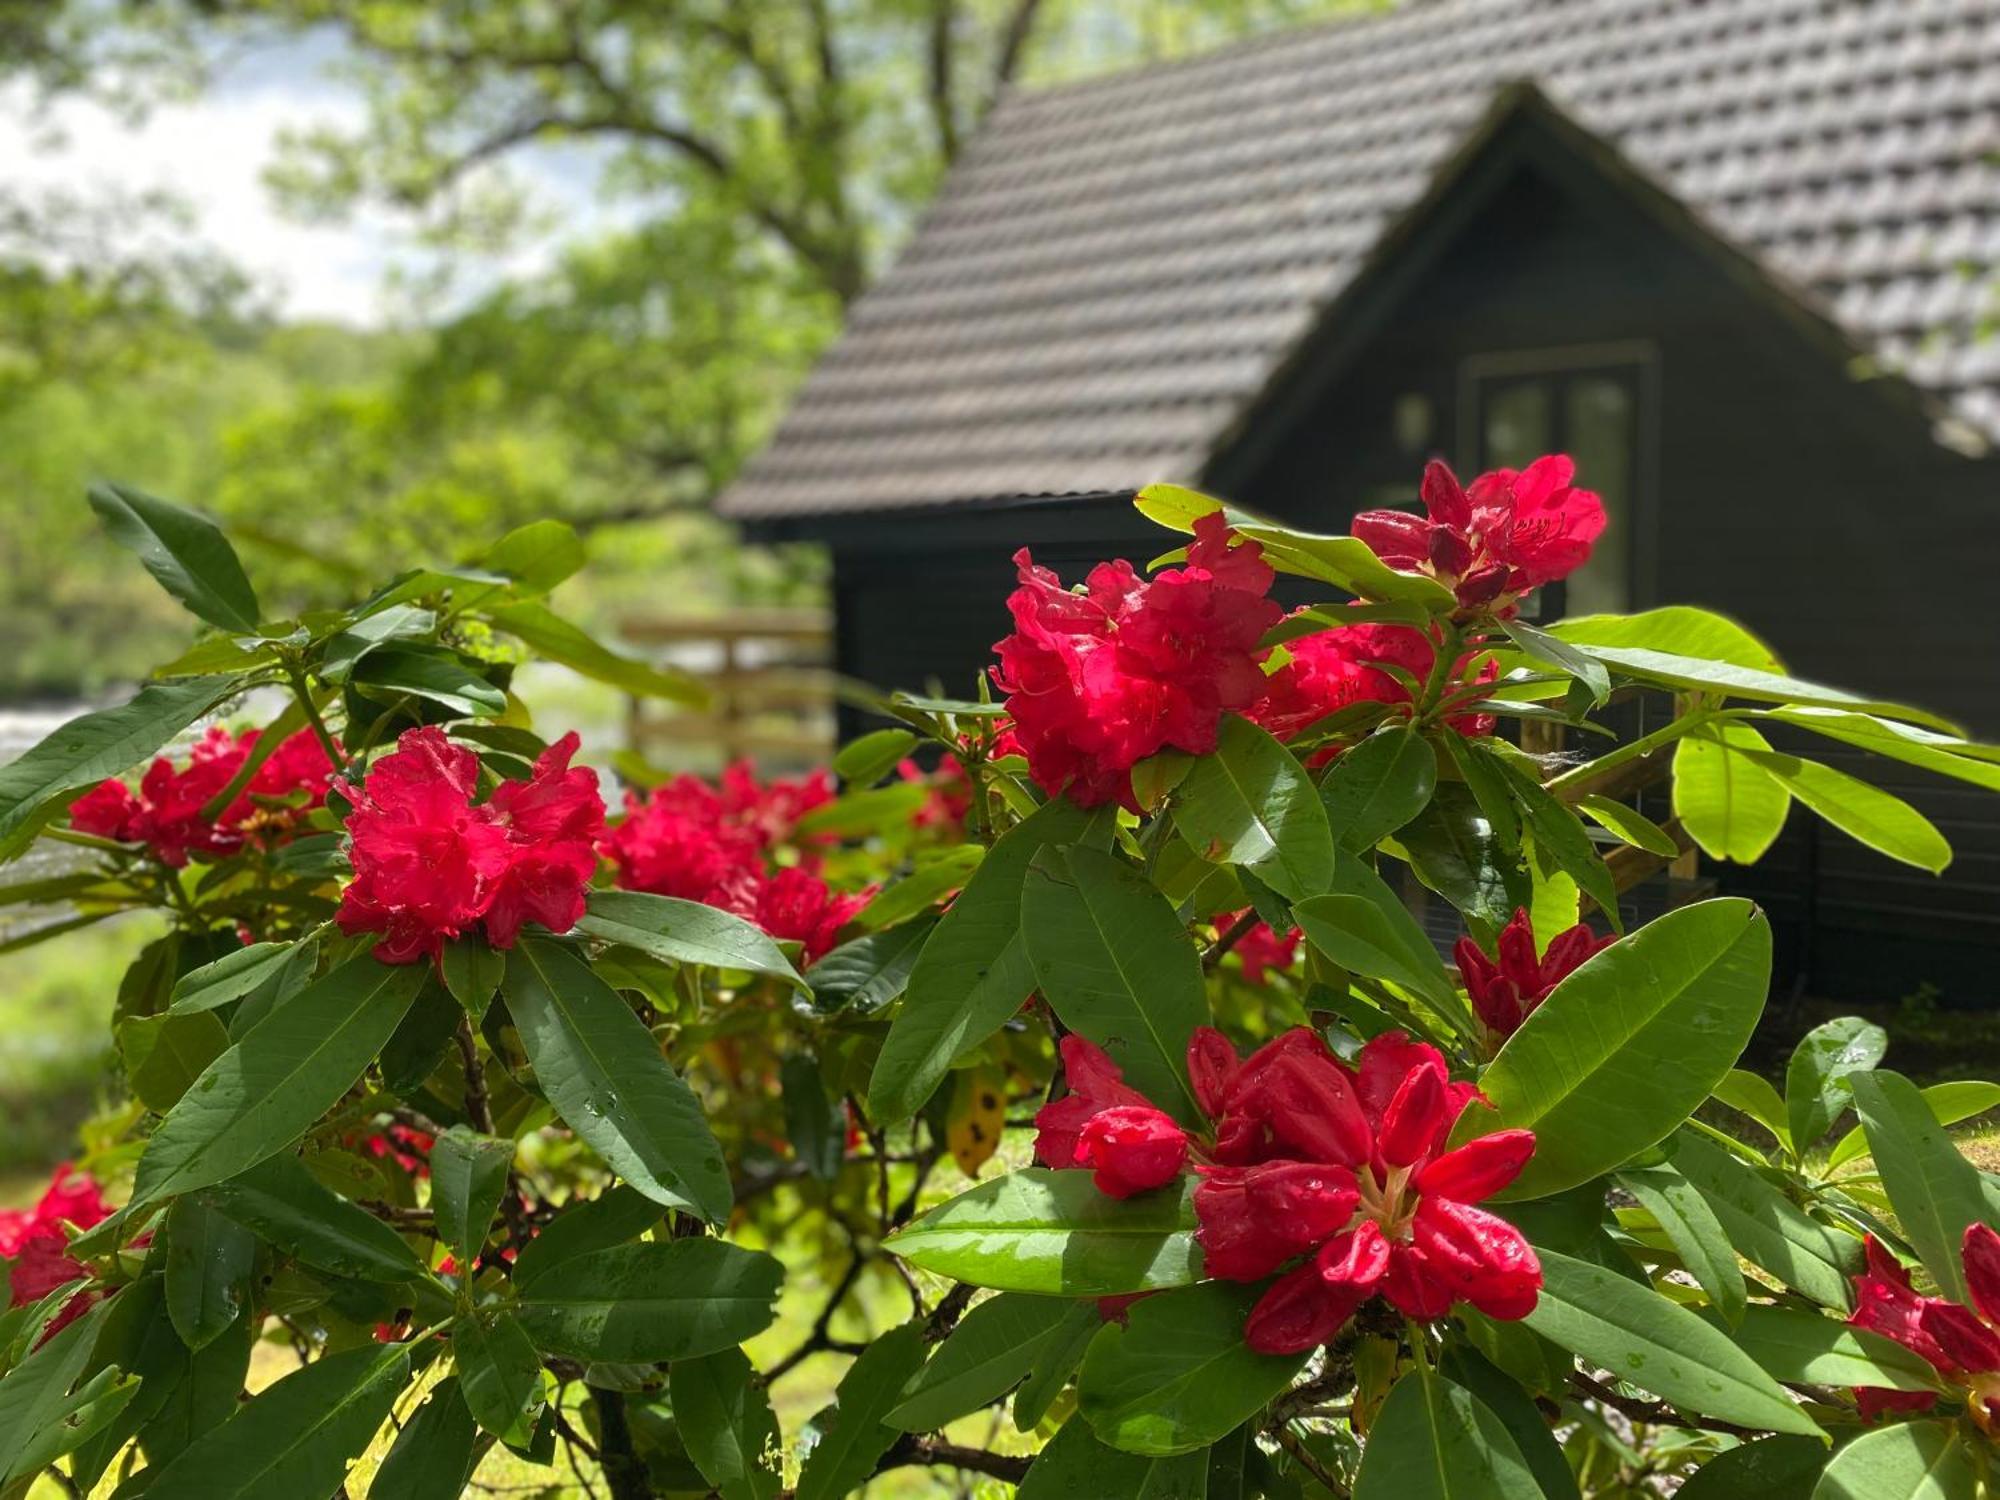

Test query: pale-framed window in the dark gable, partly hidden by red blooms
[1460,346,1656,618]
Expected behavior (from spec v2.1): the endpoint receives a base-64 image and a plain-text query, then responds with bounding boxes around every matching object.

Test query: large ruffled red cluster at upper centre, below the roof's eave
[994,512,1284,810]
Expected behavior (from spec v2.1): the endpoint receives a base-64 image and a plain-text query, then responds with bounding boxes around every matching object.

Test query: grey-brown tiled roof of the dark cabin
[722,0,2000,518]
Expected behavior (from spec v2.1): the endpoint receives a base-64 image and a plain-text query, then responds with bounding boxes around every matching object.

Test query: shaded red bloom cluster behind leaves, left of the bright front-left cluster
[70,724,334,870]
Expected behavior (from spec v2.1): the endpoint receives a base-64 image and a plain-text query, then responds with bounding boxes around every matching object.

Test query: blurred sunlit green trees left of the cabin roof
[0,0,1368,704]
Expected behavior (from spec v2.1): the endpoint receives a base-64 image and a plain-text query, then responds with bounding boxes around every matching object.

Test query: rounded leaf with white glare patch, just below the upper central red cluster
[1174,716,1334,900]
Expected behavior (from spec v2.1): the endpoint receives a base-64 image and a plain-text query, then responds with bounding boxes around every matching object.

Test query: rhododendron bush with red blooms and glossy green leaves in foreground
[0,468,2000,1500]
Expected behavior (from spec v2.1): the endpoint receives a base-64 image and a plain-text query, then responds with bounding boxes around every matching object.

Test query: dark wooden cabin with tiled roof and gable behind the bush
[722,0,2000,1002]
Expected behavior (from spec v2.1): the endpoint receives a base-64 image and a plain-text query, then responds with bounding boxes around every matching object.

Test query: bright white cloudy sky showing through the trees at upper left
[0,38,604,326]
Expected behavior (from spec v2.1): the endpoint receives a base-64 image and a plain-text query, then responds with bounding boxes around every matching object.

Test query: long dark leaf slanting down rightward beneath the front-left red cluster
[508,938,734,1224]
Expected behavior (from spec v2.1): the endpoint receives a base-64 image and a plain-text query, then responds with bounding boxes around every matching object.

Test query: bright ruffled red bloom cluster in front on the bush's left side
[336,726,604,964]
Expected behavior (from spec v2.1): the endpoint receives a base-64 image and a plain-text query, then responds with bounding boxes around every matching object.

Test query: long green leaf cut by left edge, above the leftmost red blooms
[0,676,236,860]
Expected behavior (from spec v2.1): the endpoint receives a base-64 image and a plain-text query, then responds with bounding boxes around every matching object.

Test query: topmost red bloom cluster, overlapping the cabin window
[1354,454,1604,614]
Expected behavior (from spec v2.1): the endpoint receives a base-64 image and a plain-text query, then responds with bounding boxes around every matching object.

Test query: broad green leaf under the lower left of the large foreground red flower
[1076,1282,1306,1454]
